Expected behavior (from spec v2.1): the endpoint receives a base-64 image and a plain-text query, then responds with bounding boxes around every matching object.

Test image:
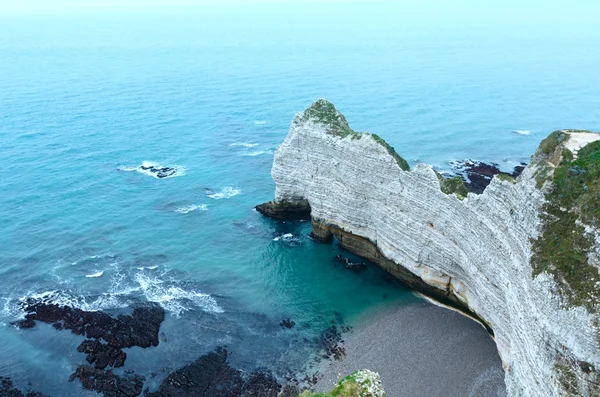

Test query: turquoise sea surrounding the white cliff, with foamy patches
[0,6,600,396]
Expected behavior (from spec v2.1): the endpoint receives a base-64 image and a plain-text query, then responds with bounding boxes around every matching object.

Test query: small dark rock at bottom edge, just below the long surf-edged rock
[69,365,146,397]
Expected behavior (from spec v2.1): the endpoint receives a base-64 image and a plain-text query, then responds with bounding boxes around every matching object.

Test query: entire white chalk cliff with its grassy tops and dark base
[257,100,600,397]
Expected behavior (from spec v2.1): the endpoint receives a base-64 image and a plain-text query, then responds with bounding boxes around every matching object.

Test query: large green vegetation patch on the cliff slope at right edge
[531,139,600,312]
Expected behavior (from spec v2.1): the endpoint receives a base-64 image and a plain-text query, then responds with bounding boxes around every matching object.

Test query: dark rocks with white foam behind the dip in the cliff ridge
[442,160,527,194]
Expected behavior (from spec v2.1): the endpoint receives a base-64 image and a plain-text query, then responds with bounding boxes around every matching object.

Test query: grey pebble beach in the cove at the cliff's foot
[314,301,506,397]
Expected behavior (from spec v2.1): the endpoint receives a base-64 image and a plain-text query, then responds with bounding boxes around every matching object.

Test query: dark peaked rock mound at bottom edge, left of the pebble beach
[145,348,244,397]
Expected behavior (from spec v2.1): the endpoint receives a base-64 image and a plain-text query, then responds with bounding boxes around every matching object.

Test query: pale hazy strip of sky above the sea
[0,0,600,23]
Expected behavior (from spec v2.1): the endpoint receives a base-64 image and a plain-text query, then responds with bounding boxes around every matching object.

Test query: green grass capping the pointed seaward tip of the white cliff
[301,99,410,171]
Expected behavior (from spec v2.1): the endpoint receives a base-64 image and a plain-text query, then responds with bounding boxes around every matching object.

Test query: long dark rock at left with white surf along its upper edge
[15,299,165,369]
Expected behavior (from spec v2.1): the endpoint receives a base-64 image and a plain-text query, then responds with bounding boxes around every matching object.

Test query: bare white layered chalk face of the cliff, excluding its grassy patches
[272,101,600,397]
